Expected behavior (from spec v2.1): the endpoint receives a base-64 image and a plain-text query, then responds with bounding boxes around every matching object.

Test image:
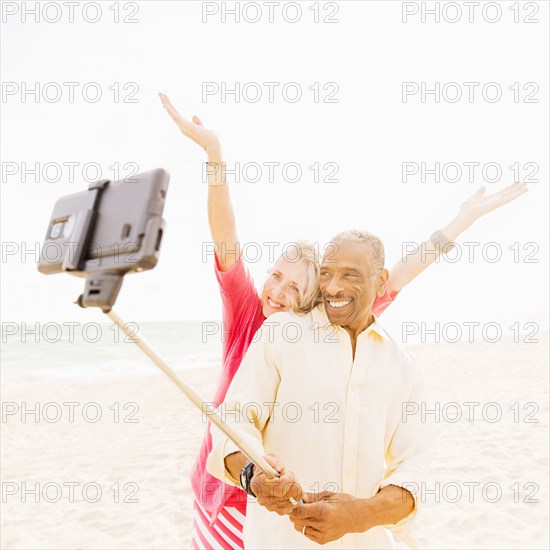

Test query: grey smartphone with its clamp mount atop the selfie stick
[37,168,170,309]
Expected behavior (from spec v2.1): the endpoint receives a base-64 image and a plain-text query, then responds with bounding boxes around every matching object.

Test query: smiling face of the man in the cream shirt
[321,241,388,330]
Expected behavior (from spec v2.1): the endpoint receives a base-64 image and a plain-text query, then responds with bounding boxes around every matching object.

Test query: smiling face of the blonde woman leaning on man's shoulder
[262,256,307,317]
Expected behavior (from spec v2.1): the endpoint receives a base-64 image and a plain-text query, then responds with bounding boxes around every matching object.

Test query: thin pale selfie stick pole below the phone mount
[105,310,279,479]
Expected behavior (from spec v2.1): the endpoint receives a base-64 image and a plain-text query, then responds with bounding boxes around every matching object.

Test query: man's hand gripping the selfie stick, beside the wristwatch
[250,454,302,516]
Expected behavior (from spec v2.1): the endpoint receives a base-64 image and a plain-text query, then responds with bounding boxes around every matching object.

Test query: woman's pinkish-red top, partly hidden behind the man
[191,254,398,521]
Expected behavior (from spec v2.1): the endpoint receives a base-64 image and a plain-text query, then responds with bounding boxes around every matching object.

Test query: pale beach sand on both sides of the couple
[1,334,549,549]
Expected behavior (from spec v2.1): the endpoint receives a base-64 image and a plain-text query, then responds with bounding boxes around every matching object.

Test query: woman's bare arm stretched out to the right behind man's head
[388,182,527,292]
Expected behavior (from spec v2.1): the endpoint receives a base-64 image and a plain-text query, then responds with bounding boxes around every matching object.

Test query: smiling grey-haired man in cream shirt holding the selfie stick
[207,231,431,549]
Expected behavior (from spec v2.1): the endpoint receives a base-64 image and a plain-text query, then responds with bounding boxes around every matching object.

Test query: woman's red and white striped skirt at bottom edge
[192,500,245,550]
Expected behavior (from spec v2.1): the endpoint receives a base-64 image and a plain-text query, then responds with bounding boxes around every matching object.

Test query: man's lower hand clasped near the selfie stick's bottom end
[289,491,366,544]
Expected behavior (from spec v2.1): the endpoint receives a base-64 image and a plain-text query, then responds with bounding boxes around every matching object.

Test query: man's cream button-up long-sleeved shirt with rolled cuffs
[207,306,432,549]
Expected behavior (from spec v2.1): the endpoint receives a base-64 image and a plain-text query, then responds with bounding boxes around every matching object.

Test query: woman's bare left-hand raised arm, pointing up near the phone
[159,94,240,271]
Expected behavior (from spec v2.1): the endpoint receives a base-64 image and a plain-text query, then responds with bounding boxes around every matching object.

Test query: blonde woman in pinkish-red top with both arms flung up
[159,94,527,548]
